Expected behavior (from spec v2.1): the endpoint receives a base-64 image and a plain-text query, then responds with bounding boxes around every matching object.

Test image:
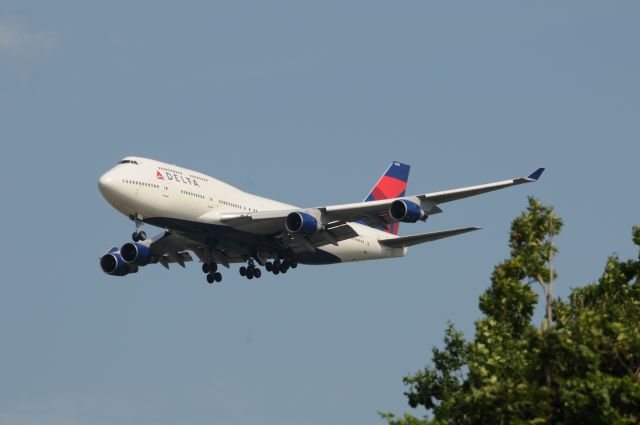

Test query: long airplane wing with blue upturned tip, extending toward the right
[211,168,544,235]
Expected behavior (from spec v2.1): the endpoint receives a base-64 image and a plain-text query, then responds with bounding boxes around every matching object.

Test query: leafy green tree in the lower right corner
[381,198,640,425]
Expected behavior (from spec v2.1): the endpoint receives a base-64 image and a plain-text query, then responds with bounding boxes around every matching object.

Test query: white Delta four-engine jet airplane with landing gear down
[98,156,544,284]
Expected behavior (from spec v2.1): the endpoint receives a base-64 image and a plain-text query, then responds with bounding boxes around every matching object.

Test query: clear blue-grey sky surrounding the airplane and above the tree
[0,0,640,425]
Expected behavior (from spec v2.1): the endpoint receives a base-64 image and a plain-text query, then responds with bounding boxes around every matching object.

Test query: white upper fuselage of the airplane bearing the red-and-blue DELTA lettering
[99,157,406,262]
